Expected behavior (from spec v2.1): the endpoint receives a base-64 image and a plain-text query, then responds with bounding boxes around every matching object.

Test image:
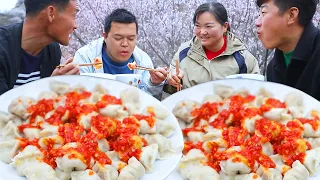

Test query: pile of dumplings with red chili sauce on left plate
[0,81,181,180]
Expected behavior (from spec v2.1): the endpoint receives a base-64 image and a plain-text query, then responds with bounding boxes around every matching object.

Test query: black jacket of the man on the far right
[267,23,320,100]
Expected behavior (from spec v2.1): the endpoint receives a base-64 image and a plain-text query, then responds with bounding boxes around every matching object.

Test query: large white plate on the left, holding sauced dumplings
[0,76,183,180]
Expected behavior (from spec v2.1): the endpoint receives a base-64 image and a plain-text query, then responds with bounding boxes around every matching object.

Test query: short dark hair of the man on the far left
[24,0,71,16]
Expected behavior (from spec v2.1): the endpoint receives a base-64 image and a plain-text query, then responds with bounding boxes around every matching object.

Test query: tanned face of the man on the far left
[48,0,79,46]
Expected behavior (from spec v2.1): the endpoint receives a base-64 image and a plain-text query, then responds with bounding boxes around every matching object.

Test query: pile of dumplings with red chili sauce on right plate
[173,85,320,180]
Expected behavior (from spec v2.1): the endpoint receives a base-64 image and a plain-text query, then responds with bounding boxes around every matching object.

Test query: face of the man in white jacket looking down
[103,22,137,62]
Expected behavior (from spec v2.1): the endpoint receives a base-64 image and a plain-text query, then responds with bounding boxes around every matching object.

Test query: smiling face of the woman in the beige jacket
[194,12,228,47]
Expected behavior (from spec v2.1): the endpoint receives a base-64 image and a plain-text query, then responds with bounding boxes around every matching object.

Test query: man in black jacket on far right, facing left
[256,0,320,100]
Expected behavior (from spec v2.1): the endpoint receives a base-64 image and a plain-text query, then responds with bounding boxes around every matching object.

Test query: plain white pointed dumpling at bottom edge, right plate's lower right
[283,160,309,180]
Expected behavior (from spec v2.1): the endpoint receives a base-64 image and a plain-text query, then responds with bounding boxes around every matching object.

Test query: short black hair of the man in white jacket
[104,9,138,33]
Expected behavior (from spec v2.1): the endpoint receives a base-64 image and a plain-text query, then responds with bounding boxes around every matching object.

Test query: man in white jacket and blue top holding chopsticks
[74,9,167,99]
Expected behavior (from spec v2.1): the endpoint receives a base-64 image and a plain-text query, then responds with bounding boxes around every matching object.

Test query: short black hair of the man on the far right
[257,0,319,27]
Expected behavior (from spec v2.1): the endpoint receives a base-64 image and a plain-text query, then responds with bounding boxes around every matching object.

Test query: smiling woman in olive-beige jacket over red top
[165,2,260,93]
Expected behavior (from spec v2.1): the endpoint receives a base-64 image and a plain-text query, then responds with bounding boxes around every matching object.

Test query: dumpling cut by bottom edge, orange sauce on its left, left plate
[92,162,119,180]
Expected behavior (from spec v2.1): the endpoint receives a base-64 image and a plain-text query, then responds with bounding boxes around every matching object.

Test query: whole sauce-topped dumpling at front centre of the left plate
[56,150,87,172]
